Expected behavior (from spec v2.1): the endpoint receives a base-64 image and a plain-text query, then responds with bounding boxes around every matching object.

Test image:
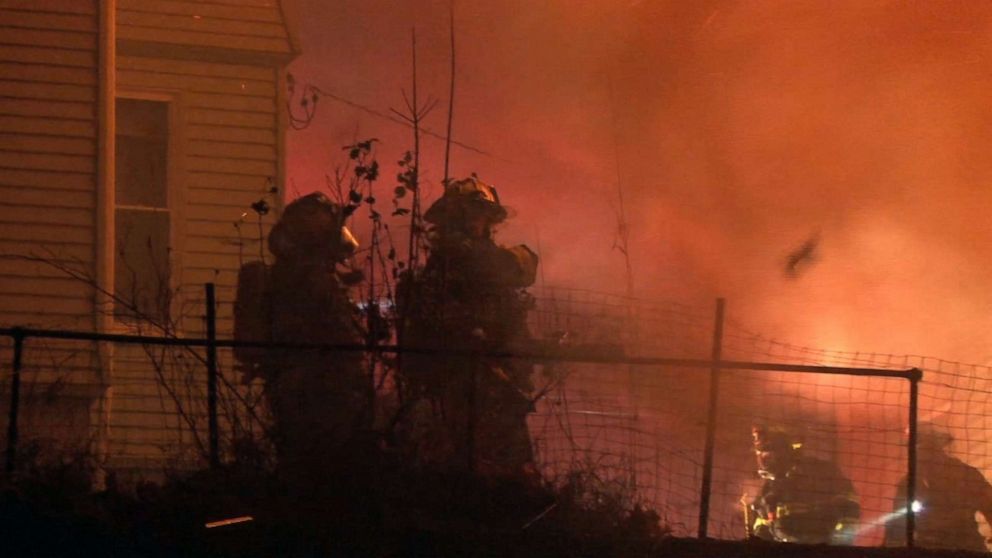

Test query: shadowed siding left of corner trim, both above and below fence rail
[0,0,103,462]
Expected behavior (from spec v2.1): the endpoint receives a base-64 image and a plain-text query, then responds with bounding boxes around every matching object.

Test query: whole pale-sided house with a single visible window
[0,0,298,482]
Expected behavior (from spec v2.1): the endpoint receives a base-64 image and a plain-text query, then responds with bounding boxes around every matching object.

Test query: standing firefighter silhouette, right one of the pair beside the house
[397,176,537,475]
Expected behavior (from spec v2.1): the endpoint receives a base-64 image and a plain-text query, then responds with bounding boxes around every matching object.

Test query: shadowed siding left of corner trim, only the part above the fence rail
[0,0,98,330]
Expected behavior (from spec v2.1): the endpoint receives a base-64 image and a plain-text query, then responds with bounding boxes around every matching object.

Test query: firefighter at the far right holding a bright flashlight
[885,423,992,552]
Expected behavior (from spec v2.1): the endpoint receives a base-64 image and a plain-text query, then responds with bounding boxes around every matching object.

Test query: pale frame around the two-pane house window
[110,88,186,333]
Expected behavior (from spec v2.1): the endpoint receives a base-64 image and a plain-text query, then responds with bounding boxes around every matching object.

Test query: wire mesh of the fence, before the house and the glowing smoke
[0,288,976,545]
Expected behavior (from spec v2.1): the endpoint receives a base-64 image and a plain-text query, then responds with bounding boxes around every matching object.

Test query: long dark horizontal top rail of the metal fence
[0,327,923,382]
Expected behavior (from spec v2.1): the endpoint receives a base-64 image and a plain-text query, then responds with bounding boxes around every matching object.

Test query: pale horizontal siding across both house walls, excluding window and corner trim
[0,0,295,474]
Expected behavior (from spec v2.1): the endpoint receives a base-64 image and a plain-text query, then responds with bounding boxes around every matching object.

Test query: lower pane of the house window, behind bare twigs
[114,209,171,320]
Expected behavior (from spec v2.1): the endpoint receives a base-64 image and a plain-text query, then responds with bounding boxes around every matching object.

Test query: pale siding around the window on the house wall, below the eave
[109,49,281,470]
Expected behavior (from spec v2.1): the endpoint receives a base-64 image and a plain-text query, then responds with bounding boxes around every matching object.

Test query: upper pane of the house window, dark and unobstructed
[115,99,169,208]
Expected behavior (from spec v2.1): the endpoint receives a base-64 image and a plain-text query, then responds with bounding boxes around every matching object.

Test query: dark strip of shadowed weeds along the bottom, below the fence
[0,441,665,557]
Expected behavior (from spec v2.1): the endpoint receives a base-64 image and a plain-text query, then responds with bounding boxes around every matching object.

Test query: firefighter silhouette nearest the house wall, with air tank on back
[235,192,367,482]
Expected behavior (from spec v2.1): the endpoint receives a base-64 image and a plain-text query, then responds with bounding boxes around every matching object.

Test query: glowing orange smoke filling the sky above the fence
[285,0,992,362]
